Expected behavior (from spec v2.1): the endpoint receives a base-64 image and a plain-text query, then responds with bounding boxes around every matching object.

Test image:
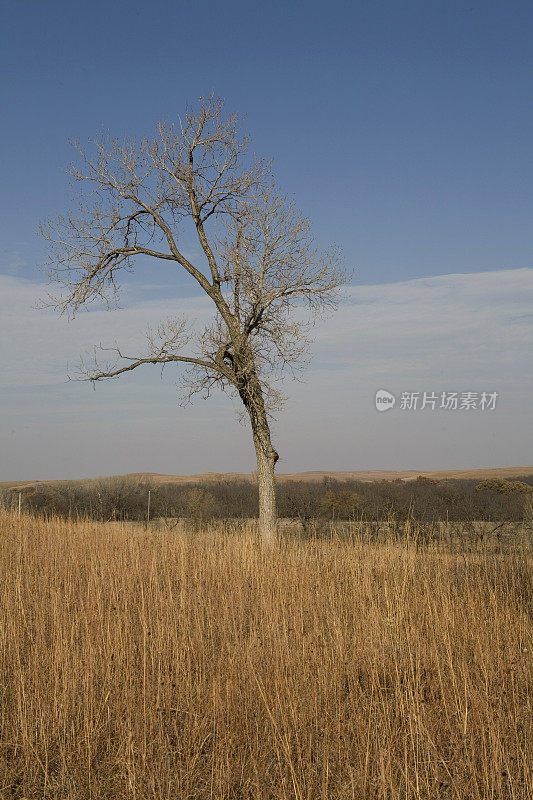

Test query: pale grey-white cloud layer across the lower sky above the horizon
[0,269,533,478]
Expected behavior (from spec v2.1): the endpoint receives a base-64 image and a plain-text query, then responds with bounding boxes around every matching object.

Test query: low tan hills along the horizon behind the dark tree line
[0,467,533,489]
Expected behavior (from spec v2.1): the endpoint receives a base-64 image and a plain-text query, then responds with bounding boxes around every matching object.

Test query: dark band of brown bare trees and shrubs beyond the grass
[2,475,533,529]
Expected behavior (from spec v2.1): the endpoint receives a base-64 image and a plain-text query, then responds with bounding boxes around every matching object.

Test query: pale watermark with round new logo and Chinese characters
[375,389,498,411]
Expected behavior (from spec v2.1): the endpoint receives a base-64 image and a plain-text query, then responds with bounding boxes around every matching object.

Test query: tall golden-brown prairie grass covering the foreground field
[0,513,533,800]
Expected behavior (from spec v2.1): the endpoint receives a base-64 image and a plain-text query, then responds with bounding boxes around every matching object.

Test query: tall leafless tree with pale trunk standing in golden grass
[41,96,346,541]
